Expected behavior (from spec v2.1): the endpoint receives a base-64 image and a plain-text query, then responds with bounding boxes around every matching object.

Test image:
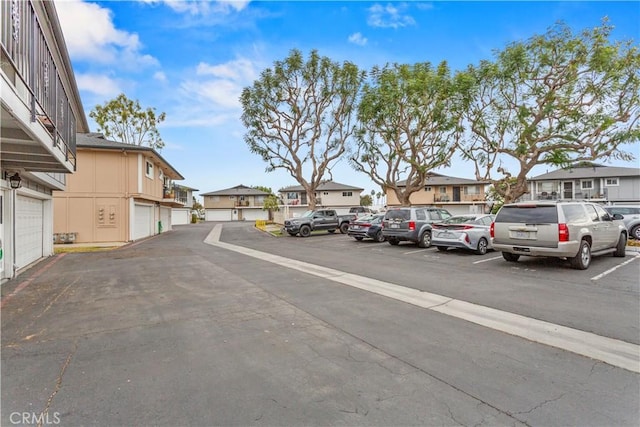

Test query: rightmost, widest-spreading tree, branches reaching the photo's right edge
[462,20,640,202]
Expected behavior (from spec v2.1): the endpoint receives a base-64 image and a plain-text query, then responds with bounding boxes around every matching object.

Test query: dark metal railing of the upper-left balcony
[0,0,76,170]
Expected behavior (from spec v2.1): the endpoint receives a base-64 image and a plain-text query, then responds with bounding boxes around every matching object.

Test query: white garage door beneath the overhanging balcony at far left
[16,196,44,268]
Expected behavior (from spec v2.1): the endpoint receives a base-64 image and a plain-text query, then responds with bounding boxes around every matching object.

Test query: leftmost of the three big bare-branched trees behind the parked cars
[240,50,364,209]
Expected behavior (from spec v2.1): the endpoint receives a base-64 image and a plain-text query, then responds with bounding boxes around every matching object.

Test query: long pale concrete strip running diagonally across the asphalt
[204,224,640,373]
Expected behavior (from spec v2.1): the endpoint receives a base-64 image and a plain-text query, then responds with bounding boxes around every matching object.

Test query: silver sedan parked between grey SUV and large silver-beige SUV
[431,214,495,255]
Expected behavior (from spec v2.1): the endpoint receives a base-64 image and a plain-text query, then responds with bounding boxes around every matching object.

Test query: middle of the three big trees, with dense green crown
[350,62,464,206]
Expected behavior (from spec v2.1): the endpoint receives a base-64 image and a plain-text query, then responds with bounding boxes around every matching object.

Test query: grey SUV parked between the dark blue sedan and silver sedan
[382,207,451,248]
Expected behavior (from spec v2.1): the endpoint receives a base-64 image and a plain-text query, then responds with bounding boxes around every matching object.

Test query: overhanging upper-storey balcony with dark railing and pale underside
[0,1,77,173]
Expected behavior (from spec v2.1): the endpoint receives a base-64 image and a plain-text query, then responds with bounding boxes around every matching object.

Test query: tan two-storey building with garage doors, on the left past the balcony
[53,133,184,243]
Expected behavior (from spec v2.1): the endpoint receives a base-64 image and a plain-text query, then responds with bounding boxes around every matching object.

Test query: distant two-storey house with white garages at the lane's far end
[201,185,269,221]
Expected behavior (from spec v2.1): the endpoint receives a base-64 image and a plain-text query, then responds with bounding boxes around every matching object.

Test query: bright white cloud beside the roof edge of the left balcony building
[56,0,158,68]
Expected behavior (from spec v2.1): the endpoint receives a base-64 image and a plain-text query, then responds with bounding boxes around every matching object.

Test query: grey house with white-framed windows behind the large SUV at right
[524,162,640,203]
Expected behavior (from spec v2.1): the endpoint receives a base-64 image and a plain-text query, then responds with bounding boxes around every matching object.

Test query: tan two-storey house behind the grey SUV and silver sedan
[387,172,489,215]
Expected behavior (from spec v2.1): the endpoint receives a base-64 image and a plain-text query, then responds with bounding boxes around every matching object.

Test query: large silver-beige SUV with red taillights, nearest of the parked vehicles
[491,201,627,270]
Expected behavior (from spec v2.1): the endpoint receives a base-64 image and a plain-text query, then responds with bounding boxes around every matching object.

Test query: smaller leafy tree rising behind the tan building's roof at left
[89,93,166,151]
